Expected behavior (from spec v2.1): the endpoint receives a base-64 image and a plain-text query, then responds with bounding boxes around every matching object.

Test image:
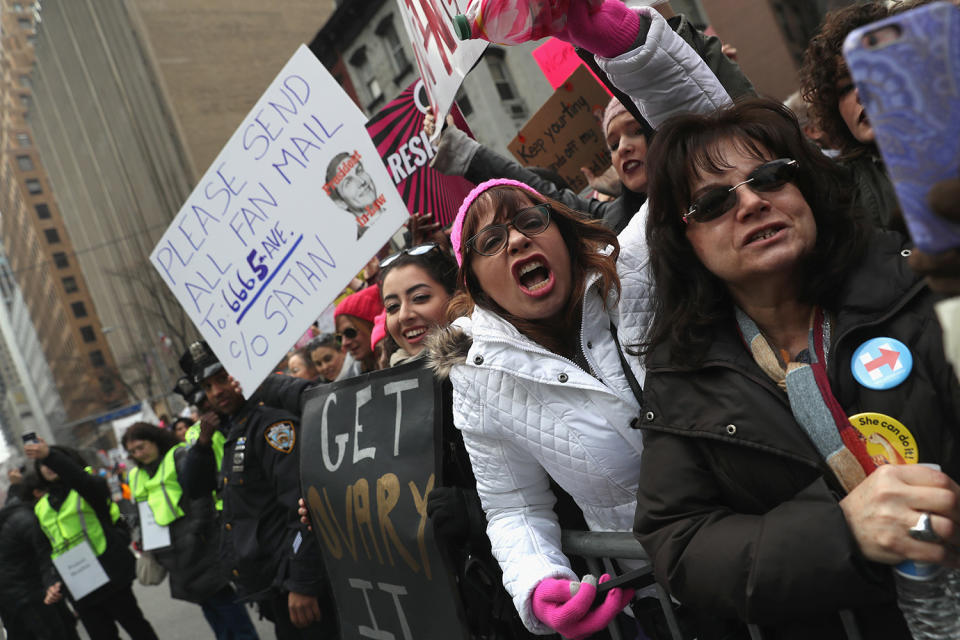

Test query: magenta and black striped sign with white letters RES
[367,80,473,225]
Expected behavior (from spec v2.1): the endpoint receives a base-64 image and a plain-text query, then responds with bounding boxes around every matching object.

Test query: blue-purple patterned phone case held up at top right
[843,2,960,253]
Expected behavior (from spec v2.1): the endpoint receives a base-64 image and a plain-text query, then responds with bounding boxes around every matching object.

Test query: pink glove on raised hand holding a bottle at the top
[555,0,640,58]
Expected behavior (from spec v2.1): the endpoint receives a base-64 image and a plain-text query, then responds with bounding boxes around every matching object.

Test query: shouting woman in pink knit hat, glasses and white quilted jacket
[430,179,646,638]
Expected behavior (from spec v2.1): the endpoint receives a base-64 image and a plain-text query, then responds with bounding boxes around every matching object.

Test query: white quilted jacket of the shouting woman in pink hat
[450,221,649,634]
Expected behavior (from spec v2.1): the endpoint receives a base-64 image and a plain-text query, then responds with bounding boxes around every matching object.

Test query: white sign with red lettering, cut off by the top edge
[397,0,487,129]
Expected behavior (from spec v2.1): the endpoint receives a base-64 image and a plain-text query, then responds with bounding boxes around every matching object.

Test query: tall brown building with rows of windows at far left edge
[0,0,126,440]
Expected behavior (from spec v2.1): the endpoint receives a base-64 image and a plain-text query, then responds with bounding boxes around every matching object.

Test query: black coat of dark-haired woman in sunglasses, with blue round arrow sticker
[635,232,960,639]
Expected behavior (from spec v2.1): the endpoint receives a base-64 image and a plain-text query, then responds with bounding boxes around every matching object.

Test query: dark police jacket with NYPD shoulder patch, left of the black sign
[187,402,324,600]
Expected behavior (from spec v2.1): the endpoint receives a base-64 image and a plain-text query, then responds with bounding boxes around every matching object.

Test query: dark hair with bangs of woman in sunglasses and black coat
[641,98,862,364]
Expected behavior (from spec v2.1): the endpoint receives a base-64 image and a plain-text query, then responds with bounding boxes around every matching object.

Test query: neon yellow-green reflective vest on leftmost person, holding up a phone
[33,467,120,558]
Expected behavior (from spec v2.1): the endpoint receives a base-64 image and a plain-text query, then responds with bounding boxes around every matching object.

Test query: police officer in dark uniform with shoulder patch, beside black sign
[186,342,338,640]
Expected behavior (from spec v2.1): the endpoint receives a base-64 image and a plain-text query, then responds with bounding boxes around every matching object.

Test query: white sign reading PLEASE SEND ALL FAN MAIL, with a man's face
[150,45,409,396]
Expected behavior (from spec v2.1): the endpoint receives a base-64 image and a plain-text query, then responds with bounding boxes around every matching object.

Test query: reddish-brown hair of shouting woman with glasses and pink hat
[447,186,620,355]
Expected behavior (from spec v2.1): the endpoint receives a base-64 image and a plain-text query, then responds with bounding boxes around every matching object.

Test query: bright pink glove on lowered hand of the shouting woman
[531,573,633,640]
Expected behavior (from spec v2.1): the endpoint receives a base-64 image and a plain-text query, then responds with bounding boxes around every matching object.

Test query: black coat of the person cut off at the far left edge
[0,498,50,612]
